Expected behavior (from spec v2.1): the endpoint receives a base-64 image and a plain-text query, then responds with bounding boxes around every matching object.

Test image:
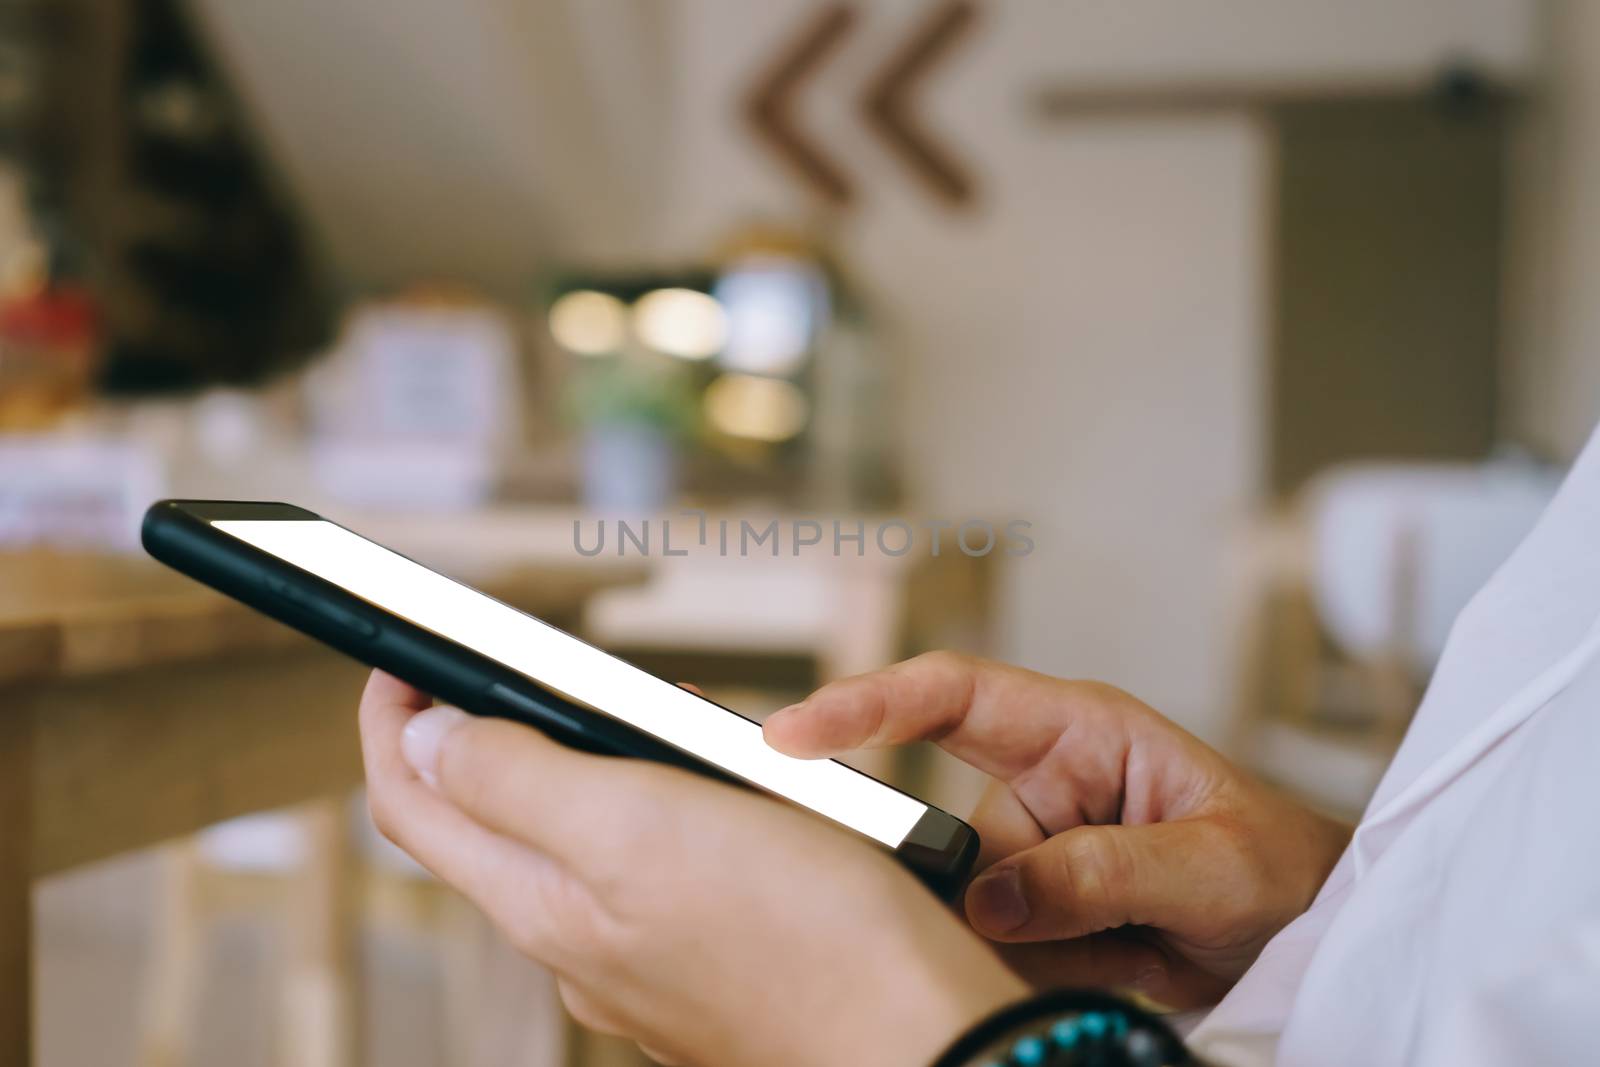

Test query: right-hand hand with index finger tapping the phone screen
[765,653,1349,1008]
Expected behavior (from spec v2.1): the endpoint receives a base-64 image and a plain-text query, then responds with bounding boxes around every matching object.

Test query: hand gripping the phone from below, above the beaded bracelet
[360,672,1027,1067]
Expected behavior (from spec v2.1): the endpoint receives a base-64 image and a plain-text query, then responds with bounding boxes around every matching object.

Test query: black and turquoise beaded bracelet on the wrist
[933,990,1195,1067]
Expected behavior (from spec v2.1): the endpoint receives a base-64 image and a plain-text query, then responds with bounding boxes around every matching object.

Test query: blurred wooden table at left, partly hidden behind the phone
[0,542,642,1065]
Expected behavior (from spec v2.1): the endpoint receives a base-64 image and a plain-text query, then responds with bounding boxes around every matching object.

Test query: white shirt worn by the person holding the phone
[1189,432,1600,1067]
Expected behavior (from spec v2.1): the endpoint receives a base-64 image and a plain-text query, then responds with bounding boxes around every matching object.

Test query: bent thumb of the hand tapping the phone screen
[966,819,1232,941]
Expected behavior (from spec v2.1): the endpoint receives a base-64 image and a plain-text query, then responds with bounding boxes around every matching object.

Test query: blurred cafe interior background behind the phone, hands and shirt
[0,0,1600,1067]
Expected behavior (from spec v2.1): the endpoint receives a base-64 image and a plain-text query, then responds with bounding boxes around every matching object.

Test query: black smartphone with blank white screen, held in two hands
[142,501,978,896]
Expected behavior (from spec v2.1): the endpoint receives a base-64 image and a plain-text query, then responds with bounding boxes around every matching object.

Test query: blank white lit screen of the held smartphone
[211,520,926,848]
